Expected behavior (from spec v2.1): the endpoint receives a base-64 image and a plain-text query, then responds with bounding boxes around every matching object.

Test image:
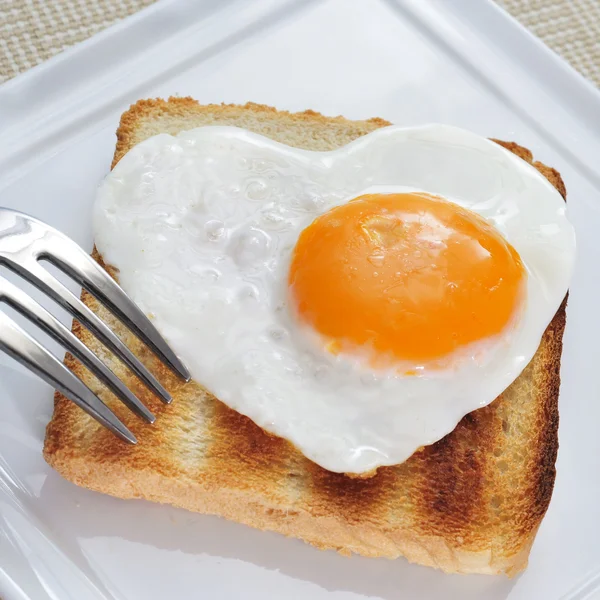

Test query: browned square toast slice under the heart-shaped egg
[44,98,566,575]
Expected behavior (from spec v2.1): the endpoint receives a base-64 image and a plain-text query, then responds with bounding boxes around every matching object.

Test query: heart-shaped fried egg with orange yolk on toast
[94,125,575,474]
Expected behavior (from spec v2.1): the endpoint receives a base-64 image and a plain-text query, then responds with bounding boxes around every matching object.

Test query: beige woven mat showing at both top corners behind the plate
[0,0,600,86]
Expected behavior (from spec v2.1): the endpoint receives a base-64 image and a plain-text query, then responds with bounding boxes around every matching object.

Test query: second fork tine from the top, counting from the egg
[10,260,172,403]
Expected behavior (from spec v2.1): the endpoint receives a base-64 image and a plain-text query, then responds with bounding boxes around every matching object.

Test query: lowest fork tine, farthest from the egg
[0,312,137,444]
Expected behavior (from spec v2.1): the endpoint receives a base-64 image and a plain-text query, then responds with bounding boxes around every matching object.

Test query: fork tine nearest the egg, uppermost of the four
[44,232,190,381]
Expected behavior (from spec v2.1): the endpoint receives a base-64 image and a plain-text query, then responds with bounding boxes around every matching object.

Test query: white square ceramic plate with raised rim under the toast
[0,0,600,600]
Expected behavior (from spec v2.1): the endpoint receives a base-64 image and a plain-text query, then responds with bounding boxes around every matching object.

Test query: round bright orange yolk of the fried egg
[288,193,526,364]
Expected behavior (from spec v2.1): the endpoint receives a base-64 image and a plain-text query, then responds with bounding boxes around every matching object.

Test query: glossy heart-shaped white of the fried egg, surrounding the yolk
[94,125,575,473]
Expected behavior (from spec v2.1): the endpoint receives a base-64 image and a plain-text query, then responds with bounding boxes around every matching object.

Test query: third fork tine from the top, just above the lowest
[0,278,155,423]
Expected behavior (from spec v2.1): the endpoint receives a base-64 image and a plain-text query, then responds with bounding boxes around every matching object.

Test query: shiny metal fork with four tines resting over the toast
[0,208,190,444]
